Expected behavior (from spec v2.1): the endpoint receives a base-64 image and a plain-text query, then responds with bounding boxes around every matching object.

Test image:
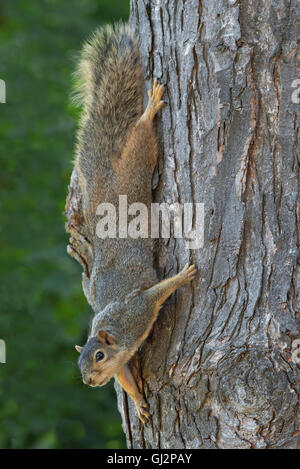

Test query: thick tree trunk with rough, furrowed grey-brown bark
[67,0,300,449]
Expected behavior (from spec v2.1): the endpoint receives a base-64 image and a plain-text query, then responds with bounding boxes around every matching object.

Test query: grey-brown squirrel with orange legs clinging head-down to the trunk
[70,23,196,423]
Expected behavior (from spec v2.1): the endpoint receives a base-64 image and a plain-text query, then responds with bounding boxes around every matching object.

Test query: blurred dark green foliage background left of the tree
[0,0,129,449]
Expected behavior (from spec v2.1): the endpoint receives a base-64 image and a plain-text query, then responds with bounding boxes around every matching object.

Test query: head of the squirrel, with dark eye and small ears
[75,329,124,386]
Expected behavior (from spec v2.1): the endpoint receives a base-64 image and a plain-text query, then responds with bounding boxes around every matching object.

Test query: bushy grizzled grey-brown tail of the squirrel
[74,23,142,158]
